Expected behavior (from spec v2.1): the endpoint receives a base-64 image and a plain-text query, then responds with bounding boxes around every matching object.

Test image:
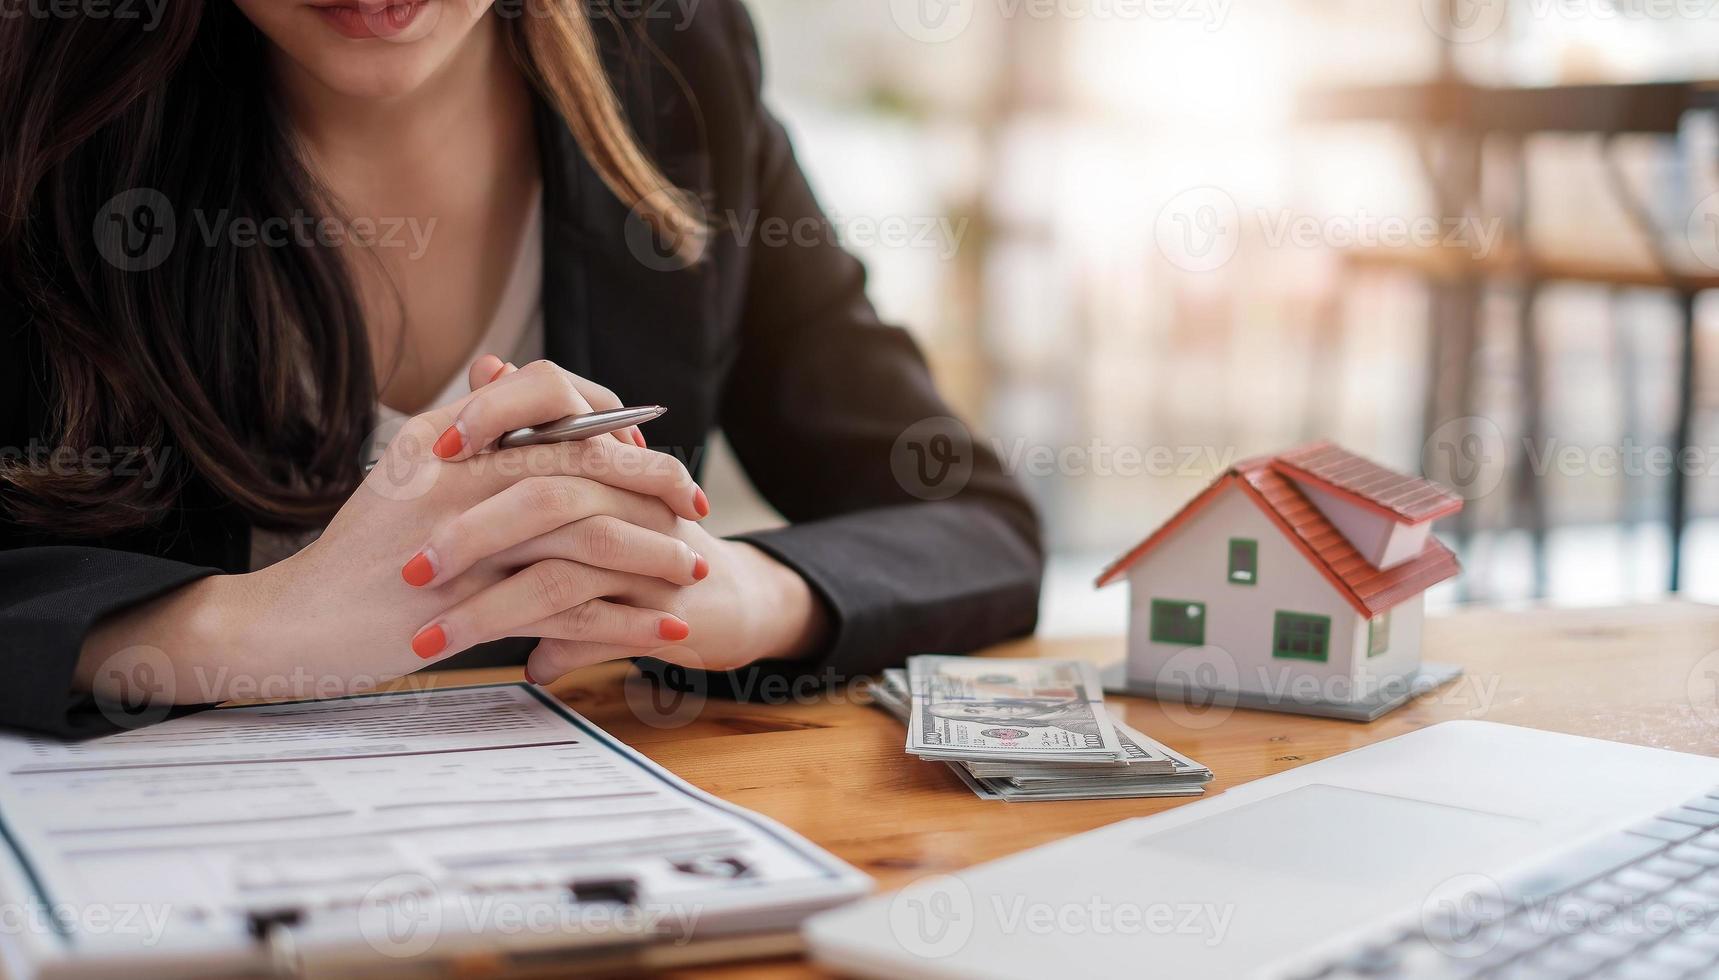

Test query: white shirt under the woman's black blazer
[251,187,543,571]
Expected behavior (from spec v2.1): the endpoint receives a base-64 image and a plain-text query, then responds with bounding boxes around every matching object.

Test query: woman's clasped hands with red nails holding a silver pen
[254,356,825,684]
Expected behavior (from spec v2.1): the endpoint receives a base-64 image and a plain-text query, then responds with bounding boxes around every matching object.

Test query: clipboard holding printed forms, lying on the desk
[0,684,872,980]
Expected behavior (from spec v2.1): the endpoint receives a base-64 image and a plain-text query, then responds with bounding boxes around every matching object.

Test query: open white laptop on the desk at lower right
[806,722,1719,980]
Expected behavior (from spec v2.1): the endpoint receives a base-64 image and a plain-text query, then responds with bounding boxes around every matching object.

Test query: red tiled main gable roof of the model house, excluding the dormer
[1098,447,1461,619]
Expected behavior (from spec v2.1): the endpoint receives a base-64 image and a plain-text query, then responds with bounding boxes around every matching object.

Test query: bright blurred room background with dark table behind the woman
[707,0,1719,634]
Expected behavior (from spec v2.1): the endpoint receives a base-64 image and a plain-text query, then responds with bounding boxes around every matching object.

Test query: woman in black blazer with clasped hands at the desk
[0,0,1042,734]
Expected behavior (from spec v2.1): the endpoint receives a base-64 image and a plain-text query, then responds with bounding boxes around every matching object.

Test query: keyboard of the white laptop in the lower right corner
[1294,787,1719,980]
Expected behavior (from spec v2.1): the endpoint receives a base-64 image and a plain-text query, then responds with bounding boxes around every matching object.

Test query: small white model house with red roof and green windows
[1098,442,1463,720]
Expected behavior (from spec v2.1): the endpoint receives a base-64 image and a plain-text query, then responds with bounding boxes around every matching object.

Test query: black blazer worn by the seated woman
[0,0,1042,734]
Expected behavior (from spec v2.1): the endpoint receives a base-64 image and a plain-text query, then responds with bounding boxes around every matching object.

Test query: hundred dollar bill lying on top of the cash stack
[908,657,1128,762]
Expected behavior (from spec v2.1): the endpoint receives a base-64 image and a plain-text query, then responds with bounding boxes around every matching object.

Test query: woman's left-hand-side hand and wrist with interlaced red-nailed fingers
[79,364,708,703]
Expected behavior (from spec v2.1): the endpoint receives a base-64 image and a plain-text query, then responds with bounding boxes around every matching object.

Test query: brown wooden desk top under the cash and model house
[404,602,1719,978]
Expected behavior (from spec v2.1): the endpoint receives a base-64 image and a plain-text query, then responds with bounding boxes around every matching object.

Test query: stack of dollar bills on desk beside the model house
[872,657,1212,801]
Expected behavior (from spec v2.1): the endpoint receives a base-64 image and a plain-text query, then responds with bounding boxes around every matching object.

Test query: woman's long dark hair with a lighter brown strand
[0,0,696,536]
